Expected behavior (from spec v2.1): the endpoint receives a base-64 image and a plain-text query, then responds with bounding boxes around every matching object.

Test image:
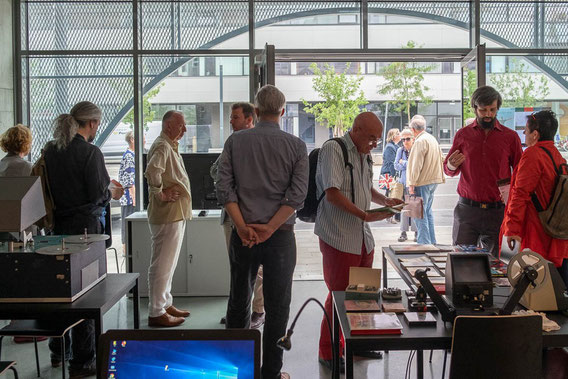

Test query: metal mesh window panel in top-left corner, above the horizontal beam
[27,2,132,50]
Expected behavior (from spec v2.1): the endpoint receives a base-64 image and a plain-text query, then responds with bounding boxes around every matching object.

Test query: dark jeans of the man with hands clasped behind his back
[226,230,296,379]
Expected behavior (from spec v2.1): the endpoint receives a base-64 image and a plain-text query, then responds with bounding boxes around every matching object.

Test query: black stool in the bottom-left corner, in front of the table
[0,319,83,379]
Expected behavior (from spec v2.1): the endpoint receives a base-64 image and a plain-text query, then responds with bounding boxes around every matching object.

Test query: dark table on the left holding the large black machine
[0,273,140,349]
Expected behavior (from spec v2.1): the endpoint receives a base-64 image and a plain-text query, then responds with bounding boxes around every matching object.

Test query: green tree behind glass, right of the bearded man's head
[488,58,550,108]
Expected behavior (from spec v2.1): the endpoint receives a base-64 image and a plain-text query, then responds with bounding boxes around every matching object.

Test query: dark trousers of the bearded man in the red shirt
[452,202,505,257]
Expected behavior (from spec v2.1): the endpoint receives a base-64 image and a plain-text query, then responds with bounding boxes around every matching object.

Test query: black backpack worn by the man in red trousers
[297,138,355,222]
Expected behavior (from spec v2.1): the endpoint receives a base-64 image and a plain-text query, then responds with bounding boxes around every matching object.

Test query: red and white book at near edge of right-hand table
[347,312,402,335]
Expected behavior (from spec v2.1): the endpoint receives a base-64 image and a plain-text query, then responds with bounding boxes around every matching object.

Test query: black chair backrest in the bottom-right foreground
[450,315,543,379]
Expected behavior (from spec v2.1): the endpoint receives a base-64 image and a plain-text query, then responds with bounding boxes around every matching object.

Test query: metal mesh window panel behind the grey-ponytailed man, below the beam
[30,57,133,160]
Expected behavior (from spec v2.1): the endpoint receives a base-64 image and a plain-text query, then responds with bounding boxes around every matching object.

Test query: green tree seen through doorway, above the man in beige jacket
[378,41,434,123]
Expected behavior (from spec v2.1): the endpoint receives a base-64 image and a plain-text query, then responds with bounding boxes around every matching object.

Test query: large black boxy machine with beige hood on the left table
[0,176,110,303]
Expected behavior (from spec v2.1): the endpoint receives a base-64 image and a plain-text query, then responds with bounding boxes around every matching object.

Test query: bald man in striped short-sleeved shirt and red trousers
[314,112,402,369]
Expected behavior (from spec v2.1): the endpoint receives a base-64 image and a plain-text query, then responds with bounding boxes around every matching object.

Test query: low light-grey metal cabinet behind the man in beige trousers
[126,210,230,296]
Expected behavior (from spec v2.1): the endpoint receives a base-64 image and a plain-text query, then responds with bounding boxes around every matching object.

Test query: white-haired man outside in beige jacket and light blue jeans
[406,115,445,244]
